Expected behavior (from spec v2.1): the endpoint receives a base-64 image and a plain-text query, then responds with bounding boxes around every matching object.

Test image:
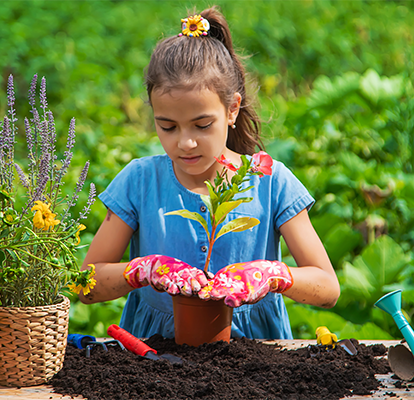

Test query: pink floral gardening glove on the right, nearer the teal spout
[198,260,293,307]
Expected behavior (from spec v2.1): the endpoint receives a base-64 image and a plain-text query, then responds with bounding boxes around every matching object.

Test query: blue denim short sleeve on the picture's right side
[272,161,315,229]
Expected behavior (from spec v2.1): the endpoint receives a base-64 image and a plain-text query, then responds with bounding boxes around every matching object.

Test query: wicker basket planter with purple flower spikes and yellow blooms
[0,75,96,386]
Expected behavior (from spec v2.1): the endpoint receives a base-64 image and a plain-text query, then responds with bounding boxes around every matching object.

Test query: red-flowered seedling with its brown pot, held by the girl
[165,151,273,346]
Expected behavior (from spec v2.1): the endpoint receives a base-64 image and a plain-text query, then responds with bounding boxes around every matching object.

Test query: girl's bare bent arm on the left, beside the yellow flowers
[79,209,133,304]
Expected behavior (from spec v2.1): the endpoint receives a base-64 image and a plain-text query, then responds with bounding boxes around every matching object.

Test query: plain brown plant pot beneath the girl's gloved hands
[173,295,233,346]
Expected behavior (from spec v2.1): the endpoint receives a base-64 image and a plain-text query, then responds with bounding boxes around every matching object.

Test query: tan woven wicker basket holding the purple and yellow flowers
[0,297,70,386]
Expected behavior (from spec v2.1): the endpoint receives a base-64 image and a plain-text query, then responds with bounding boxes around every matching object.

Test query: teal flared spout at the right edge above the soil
[374,290,414,354]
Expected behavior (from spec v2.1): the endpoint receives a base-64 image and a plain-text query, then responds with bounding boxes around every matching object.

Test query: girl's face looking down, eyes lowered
[151,89,241,193]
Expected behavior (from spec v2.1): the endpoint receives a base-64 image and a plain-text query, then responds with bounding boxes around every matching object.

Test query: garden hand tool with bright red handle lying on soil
[107,324,183,364]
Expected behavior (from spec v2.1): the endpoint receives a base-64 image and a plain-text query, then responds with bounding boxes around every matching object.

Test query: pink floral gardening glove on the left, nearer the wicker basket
[124,254,208,296]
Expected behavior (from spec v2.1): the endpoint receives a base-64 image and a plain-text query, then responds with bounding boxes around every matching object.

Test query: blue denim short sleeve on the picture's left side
[98,160,140,231]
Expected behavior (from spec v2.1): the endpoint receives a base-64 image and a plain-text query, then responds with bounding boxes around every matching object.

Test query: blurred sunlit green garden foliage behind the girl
[0,0,414,339]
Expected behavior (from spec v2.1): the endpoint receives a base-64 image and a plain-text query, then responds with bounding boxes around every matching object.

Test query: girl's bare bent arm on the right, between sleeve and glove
[280,209,340,308]
